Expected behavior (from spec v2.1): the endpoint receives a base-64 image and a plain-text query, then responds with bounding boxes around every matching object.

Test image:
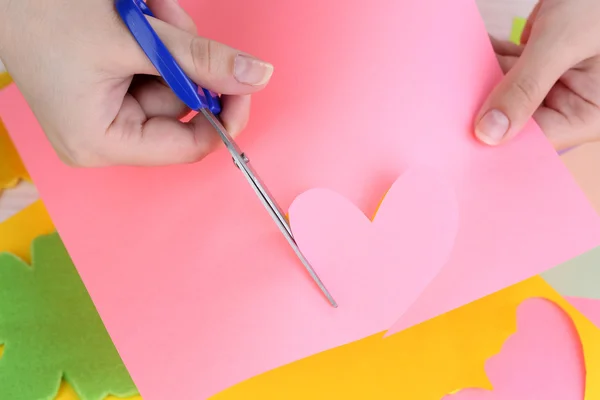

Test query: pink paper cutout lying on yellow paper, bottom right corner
[444,299,585,400]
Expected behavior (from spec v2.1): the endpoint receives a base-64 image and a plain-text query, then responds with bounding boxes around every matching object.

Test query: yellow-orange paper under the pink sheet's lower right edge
[212,277,600,400]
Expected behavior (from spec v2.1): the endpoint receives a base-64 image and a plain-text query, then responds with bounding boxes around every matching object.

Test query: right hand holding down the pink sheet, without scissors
[475,0,600,150]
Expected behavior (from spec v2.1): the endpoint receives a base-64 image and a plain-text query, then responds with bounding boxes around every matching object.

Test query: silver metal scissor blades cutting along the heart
[201,108,337,307]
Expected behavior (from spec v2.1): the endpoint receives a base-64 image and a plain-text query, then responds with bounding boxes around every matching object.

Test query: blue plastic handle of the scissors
[115,0,221,115]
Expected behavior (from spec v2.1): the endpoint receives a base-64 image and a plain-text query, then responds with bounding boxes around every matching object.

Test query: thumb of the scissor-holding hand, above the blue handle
[146,18,273,95]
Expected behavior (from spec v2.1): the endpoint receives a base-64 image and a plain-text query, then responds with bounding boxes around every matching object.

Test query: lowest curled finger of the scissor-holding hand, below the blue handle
[99,94,220,166]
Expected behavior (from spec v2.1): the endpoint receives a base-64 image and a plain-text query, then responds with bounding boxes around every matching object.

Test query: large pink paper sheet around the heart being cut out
[0,0,600,400]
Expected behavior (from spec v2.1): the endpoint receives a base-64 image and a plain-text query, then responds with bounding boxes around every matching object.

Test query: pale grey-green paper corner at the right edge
[542,247,600,299]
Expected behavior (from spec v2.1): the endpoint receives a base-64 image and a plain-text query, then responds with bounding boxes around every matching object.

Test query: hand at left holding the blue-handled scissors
[0,0,273,167]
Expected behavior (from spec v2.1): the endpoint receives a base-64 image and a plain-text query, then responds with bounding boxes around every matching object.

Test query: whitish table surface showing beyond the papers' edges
[0,0,536,222]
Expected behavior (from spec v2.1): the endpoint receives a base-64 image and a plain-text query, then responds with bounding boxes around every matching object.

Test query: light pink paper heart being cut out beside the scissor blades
[290,169,458,324]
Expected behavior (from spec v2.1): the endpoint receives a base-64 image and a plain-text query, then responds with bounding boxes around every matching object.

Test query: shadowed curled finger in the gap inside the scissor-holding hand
[129,75,190,119]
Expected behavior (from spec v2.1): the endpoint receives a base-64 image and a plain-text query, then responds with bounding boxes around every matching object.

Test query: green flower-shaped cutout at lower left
[0,233,137,400]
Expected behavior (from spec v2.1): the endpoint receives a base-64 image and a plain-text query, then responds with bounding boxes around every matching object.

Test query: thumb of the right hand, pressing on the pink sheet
[475,36,573,145]
